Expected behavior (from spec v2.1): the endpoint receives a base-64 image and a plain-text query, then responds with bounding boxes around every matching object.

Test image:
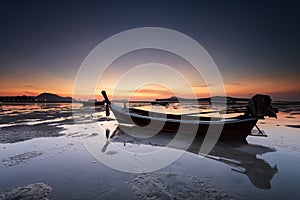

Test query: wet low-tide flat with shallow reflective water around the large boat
[0,104,300,199]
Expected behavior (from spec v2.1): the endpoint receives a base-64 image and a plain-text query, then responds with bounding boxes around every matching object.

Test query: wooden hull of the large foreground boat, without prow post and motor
[111,104,258,141]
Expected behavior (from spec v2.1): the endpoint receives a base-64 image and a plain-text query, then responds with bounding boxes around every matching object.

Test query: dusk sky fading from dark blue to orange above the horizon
[0,0,300,101]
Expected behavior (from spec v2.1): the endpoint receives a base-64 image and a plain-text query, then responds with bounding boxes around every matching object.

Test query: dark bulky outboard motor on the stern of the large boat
[246,94,278,119]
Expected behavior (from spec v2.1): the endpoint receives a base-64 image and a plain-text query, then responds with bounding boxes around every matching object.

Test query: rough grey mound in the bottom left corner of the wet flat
[0,183,52,200]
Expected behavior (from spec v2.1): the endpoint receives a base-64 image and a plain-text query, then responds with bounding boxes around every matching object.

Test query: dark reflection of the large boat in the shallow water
[101,125,278,189]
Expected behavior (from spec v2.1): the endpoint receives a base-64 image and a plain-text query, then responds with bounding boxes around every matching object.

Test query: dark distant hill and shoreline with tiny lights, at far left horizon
[0,93,73,103]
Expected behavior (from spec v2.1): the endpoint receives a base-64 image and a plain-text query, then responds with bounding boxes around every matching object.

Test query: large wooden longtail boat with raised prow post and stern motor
[102,91,276,141]
